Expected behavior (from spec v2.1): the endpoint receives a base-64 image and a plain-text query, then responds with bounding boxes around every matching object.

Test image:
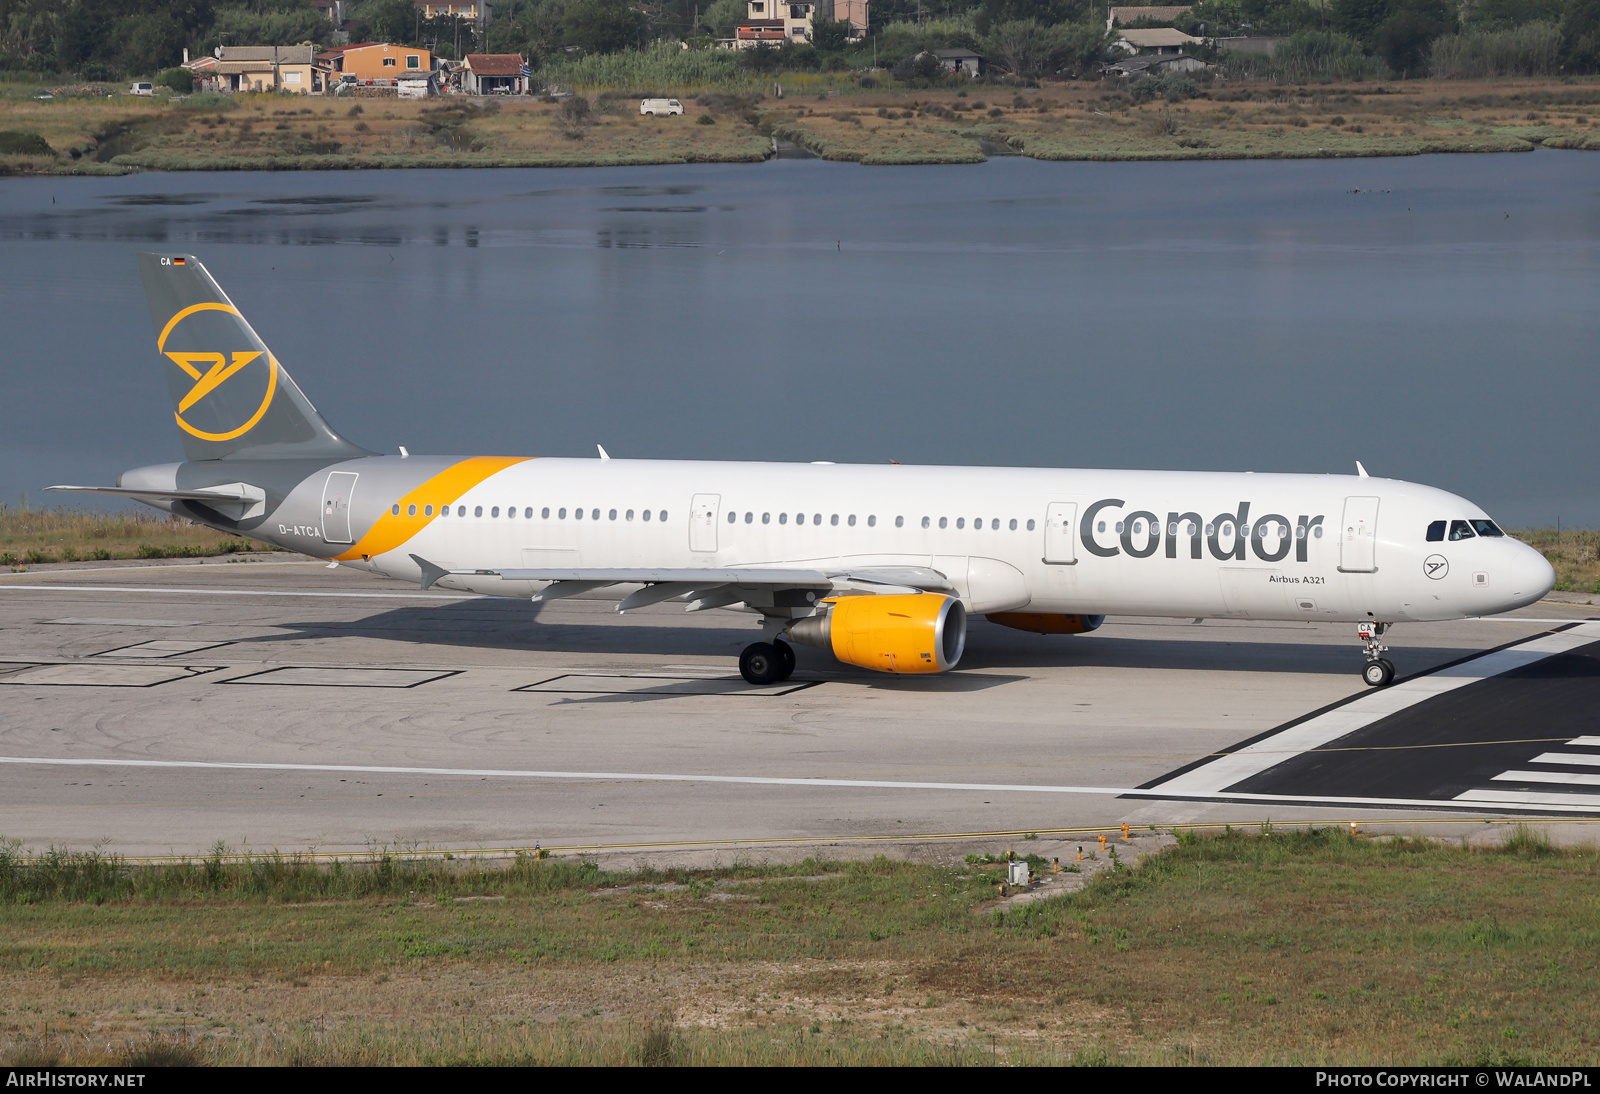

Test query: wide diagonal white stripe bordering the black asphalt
[1150,622,1600,793]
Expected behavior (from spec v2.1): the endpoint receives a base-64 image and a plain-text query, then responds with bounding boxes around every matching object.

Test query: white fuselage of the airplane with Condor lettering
[331,457,1554,622]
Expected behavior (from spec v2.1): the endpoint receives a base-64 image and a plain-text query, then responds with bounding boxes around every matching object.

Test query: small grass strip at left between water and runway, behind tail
[0,505,280,566]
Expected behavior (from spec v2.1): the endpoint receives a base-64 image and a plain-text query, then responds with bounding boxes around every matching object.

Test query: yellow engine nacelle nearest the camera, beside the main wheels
[789,593,966,672]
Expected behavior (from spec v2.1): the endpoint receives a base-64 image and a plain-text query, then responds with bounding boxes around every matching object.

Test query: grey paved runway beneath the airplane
[0,555,1600,856]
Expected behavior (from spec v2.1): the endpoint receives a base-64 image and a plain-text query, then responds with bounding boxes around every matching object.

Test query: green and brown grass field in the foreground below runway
[0,828,1600,1065]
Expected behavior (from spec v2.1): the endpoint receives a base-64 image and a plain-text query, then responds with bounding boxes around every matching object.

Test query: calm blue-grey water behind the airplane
[0,152,1600,526]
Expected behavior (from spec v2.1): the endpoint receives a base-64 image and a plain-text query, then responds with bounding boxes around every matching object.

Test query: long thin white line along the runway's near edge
[0,757,1600,813]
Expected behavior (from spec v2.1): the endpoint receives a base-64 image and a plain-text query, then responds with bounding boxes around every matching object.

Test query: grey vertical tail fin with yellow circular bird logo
[139,254,371,461]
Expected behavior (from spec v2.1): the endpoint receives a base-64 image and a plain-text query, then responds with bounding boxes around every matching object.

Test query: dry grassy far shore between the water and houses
[0,73,1600,173]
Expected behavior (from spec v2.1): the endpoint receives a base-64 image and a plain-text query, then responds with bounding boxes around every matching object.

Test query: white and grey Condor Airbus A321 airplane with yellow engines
[50,254,1555,686]
